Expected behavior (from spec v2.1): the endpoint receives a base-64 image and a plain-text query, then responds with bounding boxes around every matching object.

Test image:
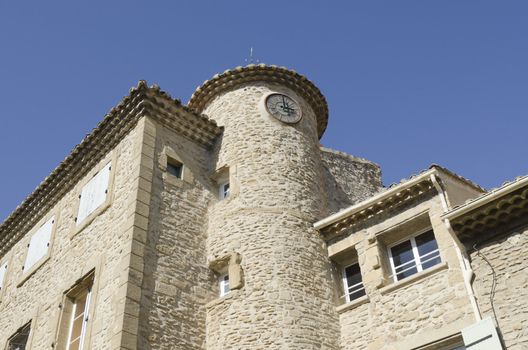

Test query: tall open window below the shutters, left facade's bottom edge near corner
[58,273,94,350]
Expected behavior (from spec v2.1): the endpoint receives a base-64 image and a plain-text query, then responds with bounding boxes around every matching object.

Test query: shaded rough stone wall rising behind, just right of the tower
[321,147,383,214]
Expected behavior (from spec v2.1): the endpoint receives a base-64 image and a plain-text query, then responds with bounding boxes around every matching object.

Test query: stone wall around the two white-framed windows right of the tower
[329,193,474,350]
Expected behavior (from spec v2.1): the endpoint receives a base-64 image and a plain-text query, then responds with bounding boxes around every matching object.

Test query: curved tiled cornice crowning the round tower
[188,64,328,138]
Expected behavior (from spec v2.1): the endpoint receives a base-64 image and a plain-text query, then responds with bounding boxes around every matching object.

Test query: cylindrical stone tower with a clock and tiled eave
[189,65,339,350]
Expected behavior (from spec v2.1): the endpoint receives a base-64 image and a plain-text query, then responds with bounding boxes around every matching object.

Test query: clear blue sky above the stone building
[0,0,528,221]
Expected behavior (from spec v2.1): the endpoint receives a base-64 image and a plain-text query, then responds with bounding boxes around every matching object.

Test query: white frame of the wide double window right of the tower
[387,227,443,283]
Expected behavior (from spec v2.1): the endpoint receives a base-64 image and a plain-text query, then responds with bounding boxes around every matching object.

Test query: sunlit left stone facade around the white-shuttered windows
[0,122,141,350]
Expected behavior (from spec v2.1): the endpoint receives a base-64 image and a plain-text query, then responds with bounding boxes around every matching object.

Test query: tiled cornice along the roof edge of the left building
[0,81,222,257]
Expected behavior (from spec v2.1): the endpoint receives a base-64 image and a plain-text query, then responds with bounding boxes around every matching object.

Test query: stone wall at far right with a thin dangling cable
[468,226,528,350]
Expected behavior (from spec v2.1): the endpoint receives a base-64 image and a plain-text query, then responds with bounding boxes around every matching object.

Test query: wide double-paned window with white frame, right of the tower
[389,230,440,282]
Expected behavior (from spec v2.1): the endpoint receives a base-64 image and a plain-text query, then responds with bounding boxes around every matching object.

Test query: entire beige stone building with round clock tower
[0,65,528,350]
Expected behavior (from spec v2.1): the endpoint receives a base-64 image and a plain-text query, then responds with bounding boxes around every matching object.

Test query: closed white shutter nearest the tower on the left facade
[77,163,111,225]
